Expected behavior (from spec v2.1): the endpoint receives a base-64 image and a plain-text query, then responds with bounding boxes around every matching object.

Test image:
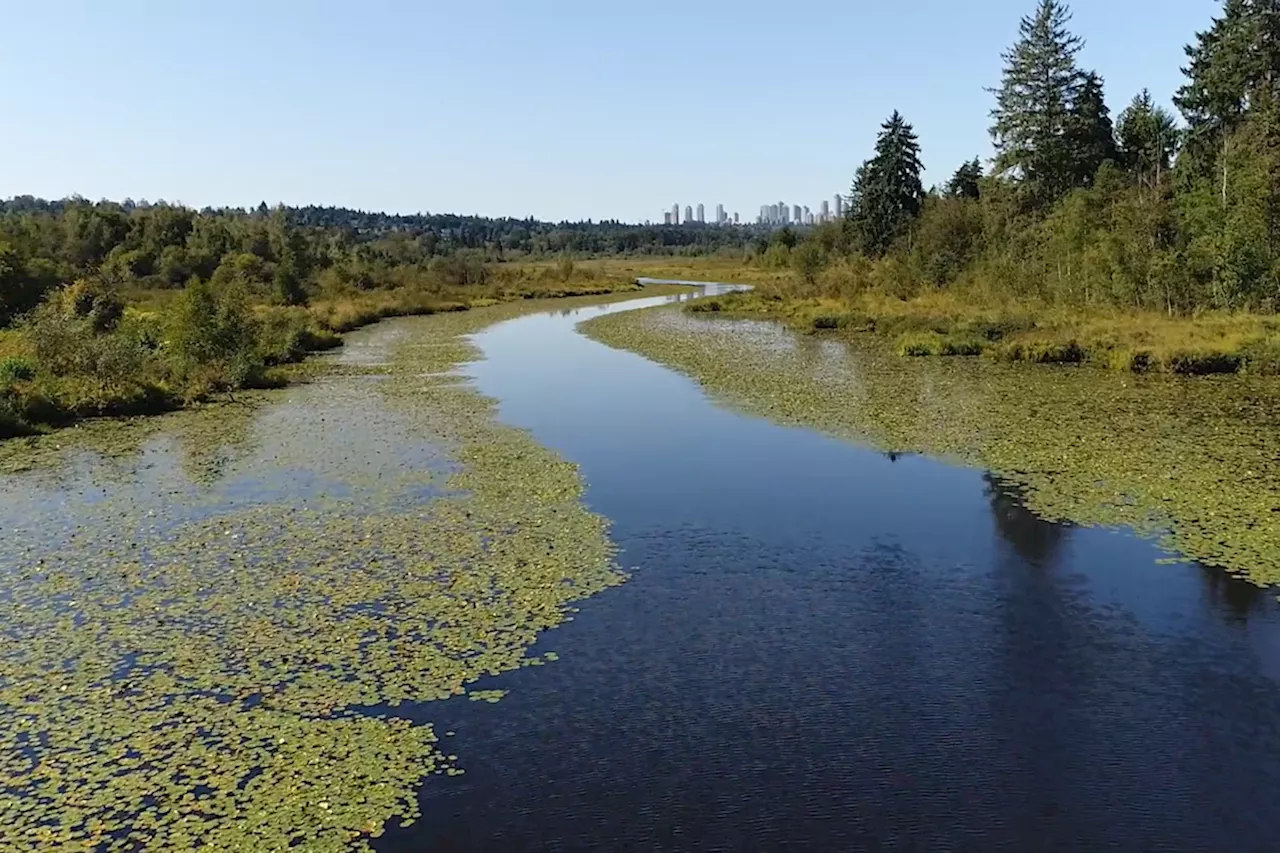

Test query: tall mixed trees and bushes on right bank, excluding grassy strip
[819,0,1280,313]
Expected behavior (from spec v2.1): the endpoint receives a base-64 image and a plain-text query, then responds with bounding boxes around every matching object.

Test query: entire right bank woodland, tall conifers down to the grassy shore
[732,0,1280,373]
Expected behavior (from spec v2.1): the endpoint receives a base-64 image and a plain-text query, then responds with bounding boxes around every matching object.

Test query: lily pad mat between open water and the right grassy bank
[582,309,1280,585]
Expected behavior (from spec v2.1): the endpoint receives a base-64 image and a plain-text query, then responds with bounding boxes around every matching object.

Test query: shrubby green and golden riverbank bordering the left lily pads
[0,264,675,439]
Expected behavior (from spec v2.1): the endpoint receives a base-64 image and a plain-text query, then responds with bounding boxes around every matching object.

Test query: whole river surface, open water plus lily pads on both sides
[0,281,1280,852]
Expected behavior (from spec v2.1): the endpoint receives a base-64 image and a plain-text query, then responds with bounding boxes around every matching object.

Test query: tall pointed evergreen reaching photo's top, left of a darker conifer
[991,0,1087,202]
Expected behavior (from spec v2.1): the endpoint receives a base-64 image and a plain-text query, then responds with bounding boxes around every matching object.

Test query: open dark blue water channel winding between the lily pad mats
[380,290,1280,853]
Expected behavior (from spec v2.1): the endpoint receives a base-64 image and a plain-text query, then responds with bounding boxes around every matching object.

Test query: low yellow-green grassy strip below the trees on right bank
[689,275,1280,375]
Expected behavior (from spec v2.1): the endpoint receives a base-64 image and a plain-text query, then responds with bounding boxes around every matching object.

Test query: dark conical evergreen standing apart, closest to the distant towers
[849,110,924,257]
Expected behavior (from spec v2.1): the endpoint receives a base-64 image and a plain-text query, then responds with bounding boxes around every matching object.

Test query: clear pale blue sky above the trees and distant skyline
[0,0,1220,220]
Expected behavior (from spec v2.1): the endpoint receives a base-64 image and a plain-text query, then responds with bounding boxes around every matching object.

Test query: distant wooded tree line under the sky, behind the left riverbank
[0,196,749,325]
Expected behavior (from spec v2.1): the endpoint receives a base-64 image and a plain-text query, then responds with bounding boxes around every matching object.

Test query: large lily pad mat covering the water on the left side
[0,289,680,852]
